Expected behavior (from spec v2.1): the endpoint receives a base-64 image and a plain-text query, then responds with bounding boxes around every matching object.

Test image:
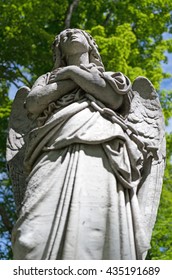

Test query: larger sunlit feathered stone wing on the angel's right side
[126,77,166,243]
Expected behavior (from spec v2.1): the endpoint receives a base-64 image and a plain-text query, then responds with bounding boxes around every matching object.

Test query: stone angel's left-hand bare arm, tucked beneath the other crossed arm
[26,80,76,116]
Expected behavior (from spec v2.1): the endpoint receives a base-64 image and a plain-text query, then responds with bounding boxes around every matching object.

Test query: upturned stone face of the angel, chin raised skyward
[60,29,90,56]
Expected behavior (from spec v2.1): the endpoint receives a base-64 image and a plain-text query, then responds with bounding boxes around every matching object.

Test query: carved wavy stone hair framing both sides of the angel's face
[52,29,104,71]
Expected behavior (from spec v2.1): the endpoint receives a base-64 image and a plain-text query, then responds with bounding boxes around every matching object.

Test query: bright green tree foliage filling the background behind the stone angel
[0,0,172,259]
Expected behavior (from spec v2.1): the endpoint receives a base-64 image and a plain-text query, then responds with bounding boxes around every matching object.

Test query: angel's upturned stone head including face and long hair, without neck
[52,28,104,69]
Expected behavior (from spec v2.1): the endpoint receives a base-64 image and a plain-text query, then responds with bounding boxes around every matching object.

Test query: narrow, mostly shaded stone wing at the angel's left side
[6,87,31,211]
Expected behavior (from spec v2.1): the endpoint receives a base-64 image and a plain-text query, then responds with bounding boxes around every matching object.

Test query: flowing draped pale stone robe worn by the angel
[12,72,150,260]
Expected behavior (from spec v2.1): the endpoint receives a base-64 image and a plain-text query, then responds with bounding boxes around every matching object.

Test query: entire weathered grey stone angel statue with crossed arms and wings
[7,29,165,260]
